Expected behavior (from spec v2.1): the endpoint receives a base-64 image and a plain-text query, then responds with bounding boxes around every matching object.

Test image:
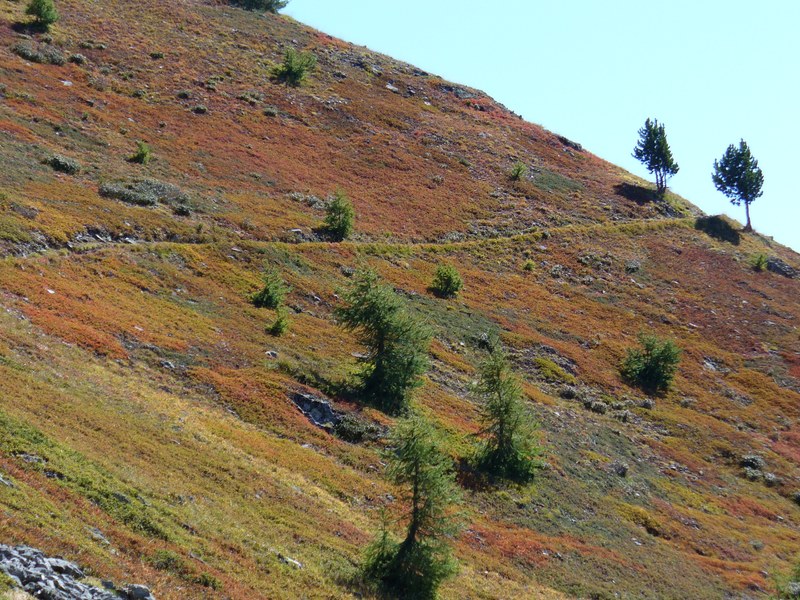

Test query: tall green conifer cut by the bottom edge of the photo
[363,416,461,599]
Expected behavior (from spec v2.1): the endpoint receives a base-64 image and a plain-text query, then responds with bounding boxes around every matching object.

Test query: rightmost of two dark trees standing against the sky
[711,140,764,231]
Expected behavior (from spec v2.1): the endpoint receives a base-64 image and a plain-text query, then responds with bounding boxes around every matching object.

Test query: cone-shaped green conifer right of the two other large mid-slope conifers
[476,348,542,482]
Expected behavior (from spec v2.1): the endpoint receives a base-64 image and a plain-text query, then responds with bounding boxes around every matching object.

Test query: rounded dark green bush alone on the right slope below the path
[620,335,681,393]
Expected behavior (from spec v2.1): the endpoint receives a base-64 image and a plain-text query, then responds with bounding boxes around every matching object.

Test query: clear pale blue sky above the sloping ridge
[283,0,800,251]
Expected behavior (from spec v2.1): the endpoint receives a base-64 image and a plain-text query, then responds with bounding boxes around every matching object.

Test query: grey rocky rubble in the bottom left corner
[0,544,155,600]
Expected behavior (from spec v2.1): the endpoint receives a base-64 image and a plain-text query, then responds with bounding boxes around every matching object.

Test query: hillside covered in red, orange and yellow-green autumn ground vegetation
[0,0,800,598]
